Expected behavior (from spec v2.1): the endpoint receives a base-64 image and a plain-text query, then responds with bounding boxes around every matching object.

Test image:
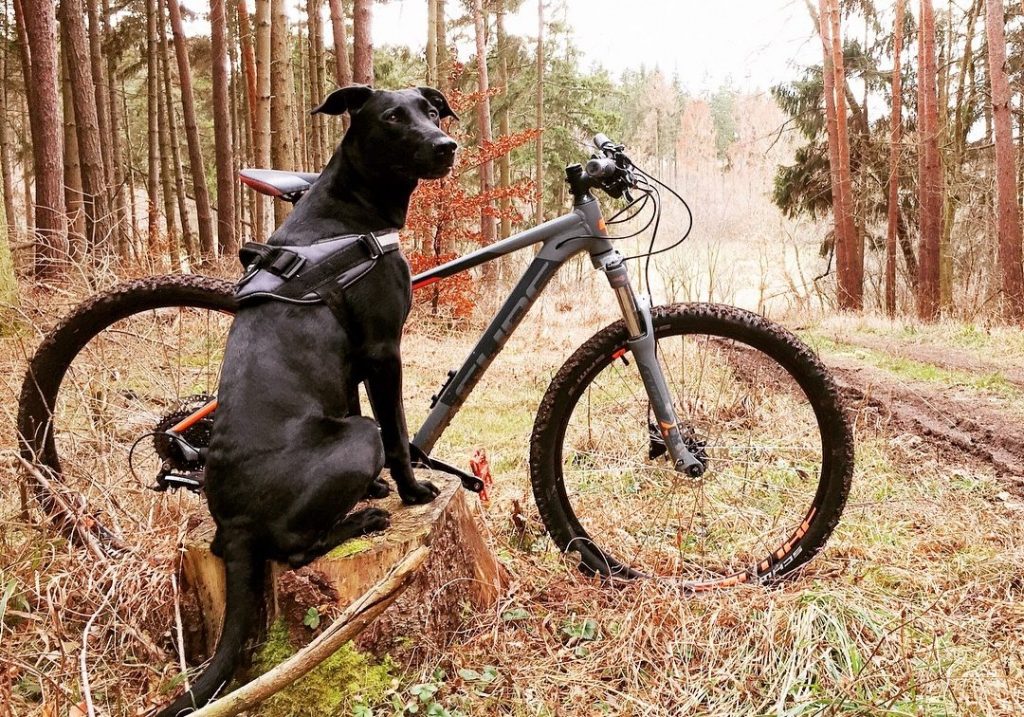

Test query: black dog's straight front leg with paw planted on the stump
[367,344,440,503]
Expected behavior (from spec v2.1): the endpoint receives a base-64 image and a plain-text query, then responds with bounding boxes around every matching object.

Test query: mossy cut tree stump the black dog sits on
[182,474,508,662]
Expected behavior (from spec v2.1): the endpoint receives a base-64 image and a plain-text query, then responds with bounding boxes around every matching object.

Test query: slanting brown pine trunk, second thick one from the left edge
[60,0,110,258]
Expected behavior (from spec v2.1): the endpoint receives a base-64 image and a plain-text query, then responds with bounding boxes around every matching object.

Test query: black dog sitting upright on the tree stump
[160,86,457,717]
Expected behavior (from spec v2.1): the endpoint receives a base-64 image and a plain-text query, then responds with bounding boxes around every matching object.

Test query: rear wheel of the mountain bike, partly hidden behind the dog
[17,276,234,551]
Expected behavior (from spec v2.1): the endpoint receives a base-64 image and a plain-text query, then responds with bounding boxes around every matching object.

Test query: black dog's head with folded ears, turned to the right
[312,85,459,179]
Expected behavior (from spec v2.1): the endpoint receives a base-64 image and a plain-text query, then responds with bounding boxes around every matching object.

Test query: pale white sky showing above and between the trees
[374,0,821,93]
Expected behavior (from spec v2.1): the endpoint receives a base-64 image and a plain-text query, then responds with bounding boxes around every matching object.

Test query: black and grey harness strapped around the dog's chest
[234,229,398,319]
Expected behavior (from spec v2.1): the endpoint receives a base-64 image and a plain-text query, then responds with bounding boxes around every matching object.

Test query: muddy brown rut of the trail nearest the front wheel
[823,354,1024,496]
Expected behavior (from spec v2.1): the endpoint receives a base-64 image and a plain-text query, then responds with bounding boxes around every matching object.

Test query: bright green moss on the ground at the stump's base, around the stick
[246,614,394,717]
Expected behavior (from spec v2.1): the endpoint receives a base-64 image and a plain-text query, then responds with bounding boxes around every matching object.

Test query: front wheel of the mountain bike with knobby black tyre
[530,304,853,590]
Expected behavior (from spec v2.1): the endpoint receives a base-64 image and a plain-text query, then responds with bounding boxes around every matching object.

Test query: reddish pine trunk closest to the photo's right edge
[985,0,1024,321]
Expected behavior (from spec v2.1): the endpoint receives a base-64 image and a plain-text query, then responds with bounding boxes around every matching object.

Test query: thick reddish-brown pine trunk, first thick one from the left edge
[14,0,68,281]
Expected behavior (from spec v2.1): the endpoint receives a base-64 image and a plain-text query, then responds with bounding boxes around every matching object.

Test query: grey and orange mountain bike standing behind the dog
[18,135,854,590]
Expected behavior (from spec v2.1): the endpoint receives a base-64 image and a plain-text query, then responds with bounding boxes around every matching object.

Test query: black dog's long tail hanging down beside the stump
[156,539,266,717]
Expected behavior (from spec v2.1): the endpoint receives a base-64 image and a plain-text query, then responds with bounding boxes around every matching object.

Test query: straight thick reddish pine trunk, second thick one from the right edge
[918,0,943,319]
